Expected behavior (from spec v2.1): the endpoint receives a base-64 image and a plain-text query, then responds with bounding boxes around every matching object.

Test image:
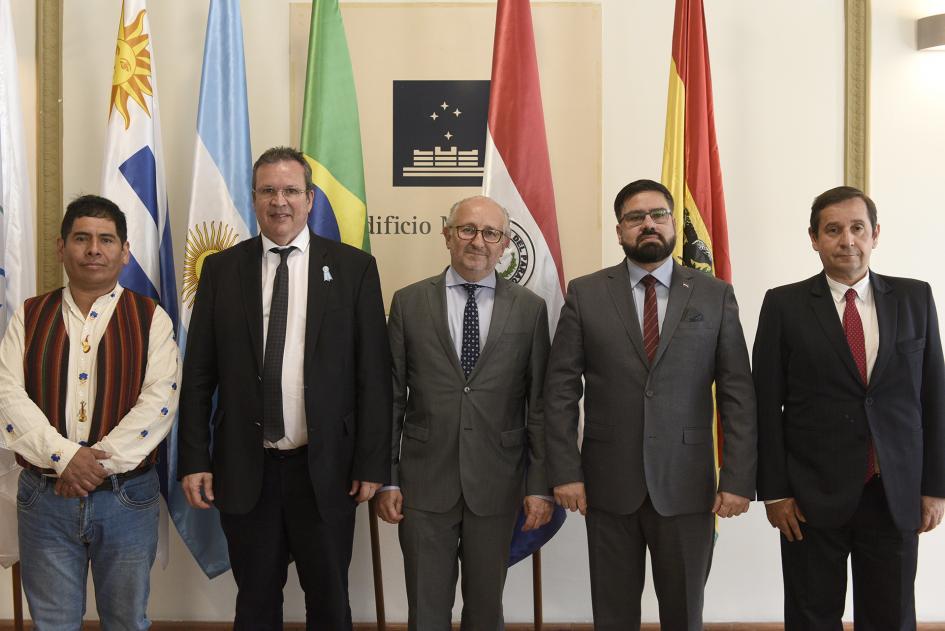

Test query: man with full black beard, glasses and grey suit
[544,180,757,631]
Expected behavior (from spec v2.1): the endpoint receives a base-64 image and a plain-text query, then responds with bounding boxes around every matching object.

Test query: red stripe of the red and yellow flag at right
[673,0,732,282]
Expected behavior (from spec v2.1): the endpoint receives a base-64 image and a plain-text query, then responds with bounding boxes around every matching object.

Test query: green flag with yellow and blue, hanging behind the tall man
[300,0,371,251]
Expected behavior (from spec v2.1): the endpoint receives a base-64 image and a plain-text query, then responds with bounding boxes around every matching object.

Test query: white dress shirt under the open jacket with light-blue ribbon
[262,228,310,449]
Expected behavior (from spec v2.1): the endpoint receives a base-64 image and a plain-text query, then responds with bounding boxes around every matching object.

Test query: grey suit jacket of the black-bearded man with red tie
[545,261,757,516]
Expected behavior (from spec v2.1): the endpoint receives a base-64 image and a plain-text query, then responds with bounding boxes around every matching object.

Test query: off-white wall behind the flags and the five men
[0,0,945,622]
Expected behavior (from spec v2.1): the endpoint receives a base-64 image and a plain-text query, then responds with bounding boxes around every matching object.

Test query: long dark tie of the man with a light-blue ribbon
[263,246,295,443]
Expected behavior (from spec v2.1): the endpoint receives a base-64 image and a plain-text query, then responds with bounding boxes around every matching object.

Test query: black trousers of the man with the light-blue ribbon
[220,450,354,631]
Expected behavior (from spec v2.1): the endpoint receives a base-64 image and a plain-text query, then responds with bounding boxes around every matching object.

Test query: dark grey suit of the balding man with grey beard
[388,274,550,630]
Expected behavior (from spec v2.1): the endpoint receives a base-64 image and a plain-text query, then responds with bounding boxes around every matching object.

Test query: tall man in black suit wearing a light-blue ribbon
[178,147,391,631]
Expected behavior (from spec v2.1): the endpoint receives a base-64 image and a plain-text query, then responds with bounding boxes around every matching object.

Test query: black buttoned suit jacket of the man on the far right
[753,272,945,530]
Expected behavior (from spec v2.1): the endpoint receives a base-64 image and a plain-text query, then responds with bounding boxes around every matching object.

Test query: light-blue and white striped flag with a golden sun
[167,0,256,578]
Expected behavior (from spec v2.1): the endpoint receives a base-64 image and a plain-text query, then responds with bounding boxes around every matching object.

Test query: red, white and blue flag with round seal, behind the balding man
[483,0,565,565]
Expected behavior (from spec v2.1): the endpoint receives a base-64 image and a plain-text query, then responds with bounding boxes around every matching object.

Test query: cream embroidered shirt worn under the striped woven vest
[0,285,180,474]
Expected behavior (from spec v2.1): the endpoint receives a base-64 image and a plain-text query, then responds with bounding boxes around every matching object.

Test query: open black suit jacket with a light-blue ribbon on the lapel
[177,235,392,517]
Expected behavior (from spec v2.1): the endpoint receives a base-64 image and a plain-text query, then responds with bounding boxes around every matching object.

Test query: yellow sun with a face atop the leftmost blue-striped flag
[108,6,152,129]
